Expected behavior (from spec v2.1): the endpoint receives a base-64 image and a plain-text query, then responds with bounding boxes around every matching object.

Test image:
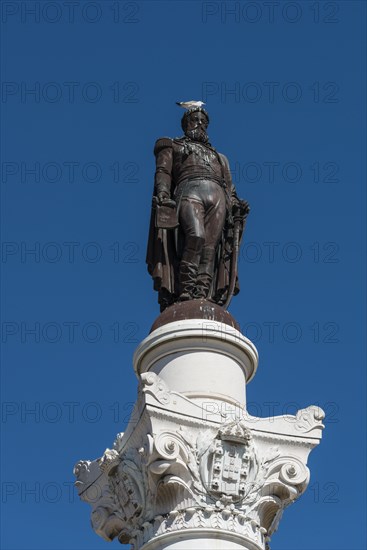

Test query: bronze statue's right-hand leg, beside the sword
[195,190,226,299]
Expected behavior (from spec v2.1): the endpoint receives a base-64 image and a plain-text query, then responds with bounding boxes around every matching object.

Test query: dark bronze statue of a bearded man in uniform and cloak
[147,107,249,311]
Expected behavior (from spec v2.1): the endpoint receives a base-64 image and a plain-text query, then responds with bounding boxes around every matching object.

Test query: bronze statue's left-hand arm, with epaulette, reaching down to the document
[154,138,173,201]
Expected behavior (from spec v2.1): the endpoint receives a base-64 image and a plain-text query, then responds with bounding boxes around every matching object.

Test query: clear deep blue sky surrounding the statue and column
[1,0,366,550]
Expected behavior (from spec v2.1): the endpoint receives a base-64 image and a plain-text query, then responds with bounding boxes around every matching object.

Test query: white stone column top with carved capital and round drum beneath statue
[74,319,324,550]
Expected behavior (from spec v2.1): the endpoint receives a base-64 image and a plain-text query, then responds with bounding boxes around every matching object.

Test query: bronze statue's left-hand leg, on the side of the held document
[179,198,205,301]
